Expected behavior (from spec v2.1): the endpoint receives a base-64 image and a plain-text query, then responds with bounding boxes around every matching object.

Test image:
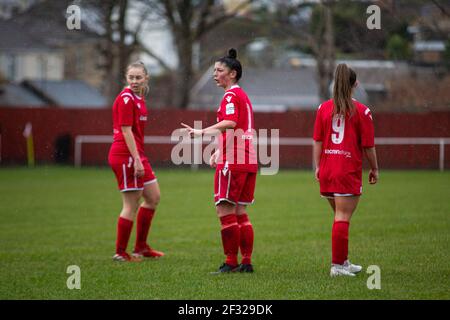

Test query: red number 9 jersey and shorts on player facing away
[313,99,375,195]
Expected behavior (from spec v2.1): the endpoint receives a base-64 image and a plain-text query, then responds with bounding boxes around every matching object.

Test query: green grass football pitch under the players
[0,167,450,300]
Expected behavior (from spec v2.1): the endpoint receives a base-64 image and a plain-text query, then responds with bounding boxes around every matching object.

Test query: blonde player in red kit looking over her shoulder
[108,62,164,261]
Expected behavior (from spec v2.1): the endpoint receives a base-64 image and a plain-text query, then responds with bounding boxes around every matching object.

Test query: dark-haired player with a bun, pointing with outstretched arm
[182,49,258,274]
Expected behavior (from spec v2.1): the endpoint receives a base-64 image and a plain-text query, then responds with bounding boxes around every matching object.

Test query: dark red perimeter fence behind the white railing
[0,107,450,169]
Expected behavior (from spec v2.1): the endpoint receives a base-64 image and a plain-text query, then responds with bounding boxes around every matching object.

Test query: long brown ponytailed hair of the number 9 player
[333,63,356,116]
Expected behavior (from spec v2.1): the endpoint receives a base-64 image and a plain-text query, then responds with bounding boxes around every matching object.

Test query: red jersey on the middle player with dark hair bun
[217,85,258,172]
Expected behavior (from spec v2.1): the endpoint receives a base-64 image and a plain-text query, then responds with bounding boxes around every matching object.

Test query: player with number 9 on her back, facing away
[313,64,378,276]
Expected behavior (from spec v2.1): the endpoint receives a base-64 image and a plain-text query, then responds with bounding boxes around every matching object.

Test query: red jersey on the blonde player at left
[110,88,147,156]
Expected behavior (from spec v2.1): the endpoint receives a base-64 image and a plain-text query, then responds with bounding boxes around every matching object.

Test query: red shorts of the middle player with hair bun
[214,169,256,205]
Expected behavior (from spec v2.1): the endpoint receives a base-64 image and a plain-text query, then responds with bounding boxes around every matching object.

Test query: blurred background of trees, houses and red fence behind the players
[0,0,450,170]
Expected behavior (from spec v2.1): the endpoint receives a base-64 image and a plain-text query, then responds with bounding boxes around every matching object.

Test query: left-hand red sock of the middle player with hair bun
[220,214,239,266]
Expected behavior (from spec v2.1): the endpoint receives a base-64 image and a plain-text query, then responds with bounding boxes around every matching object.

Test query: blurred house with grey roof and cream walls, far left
[0,0,104,89]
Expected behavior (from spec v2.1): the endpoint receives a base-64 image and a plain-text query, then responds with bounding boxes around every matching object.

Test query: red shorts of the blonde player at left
[109,156,157,192]
